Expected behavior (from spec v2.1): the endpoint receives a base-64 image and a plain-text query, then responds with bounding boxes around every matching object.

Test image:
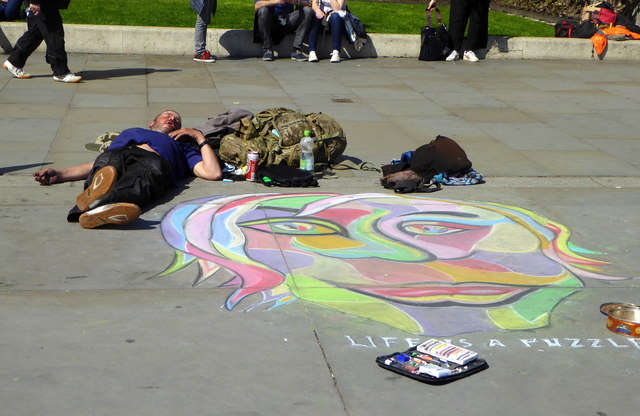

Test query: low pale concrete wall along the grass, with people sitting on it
[0,22,640,61]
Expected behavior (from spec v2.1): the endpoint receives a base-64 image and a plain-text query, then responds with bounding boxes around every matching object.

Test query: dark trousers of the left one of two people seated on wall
[255,7,313,50]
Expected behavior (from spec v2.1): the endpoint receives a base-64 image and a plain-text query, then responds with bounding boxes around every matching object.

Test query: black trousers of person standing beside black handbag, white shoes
[449,0,490,52]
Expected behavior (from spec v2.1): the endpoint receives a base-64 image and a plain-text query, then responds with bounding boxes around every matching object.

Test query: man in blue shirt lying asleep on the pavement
[33,110,222,228]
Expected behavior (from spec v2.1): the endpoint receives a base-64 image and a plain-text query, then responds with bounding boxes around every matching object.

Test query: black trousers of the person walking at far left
[8,2,71,76]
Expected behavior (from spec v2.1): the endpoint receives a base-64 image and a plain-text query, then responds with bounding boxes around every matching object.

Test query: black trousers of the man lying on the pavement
[67,146,173,222]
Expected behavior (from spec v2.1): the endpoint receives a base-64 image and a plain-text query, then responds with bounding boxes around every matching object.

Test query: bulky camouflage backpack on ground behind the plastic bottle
[219,107,347,167]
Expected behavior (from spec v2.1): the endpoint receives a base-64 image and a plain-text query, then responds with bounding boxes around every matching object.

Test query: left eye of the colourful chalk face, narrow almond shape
[239,218,344,236]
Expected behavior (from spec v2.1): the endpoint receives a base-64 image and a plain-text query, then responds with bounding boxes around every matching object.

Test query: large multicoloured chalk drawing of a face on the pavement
[156,193,621,336]
